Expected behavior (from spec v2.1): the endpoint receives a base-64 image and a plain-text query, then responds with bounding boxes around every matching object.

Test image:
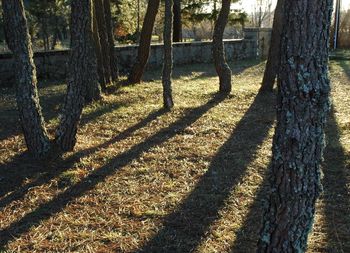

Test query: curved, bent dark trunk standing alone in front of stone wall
[213,0,232,93]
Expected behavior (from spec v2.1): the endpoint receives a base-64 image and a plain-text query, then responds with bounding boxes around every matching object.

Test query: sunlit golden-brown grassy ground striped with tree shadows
[0,60,350,253]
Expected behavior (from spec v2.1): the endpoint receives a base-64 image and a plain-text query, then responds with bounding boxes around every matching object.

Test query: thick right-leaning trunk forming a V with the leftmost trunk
[56,0,97,151]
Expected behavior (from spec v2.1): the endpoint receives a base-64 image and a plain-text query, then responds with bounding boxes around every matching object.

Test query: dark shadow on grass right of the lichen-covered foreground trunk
[323,111,350,253]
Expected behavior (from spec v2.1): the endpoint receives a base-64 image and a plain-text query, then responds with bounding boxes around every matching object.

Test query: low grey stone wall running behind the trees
[0,29,270,87]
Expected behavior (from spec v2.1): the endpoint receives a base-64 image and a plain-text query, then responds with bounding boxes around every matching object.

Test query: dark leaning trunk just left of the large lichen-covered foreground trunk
[261,0,284,92]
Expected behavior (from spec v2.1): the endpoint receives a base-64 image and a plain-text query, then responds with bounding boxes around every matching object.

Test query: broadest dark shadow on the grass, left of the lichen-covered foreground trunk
[137,90,275,253]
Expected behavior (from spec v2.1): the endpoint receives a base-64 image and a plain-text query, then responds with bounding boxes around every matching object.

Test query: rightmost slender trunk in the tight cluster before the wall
[104,0,119,81]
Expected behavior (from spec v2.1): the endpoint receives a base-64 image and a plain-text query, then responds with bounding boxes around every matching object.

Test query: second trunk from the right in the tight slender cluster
[94,0,113,87]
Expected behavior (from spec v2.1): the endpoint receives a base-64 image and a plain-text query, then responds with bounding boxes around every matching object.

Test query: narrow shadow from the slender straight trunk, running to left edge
[0,109,165,210]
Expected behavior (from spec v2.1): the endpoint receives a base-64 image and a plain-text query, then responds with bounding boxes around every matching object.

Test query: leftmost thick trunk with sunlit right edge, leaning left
[2,0,50,158]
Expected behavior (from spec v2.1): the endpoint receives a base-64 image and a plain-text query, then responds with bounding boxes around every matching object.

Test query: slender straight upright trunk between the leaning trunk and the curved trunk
[162,0,174,109]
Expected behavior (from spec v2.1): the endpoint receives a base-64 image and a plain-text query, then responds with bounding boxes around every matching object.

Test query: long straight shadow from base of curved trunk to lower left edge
[0,92,225,249]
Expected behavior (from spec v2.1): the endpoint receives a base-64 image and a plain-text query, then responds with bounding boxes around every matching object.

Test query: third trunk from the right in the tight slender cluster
[92,0,107,91]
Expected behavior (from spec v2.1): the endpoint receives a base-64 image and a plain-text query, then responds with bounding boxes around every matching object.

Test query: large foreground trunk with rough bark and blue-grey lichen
[257,0,332,252]
